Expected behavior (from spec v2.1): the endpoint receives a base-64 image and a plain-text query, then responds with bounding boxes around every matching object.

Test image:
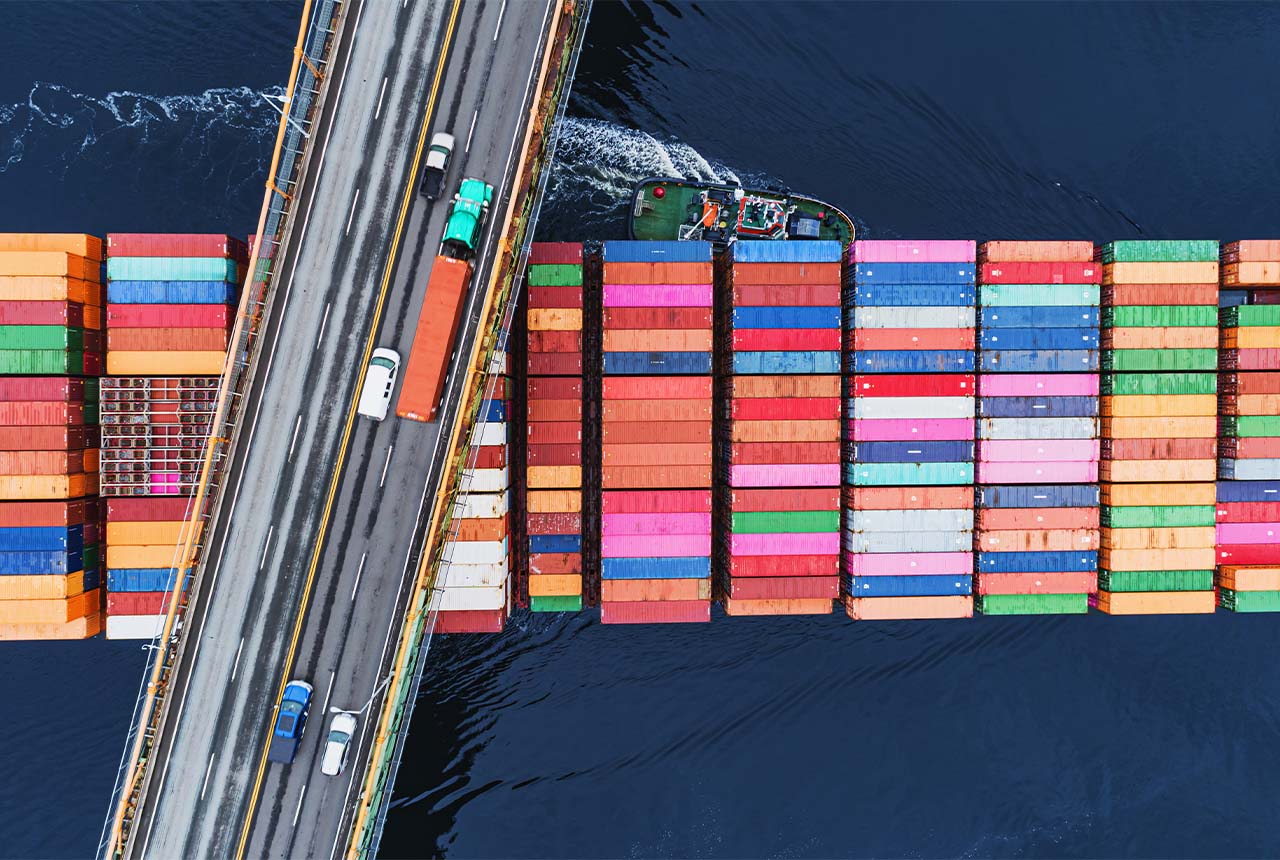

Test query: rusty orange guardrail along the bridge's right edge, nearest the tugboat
[347,0,591,860]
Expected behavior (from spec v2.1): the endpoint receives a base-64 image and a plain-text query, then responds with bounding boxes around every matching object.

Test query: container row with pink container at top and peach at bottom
[844,241,975,618]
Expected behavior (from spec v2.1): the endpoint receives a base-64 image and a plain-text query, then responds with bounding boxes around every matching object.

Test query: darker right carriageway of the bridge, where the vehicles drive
[246,0,552,857]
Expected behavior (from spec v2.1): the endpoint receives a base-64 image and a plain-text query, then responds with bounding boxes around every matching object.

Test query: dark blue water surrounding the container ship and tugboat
[0,3,1280,857]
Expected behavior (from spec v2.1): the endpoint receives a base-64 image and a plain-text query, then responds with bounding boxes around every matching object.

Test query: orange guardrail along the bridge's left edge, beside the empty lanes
[97,0,344,860]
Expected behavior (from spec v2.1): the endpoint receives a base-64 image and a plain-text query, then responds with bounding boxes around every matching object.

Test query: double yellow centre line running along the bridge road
[236,0,462,860]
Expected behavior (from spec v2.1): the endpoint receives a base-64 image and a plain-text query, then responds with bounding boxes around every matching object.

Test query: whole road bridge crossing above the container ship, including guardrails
[99,0,589,859]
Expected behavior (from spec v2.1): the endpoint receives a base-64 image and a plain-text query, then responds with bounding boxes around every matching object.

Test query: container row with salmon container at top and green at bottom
[974,242,1102,614]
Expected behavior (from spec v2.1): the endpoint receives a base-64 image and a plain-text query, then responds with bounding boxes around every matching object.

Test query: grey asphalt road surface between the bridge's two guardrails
[132,0,560,859]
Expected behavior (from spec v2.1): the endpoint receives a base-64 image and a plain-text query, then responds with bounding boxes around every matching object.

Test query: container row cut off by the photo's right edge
[1217,239,1280,612]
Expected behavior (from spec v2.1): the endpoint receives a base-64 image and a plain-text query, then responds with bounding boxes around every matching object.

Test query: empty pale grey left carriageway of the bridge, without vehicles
[132,0,460,857]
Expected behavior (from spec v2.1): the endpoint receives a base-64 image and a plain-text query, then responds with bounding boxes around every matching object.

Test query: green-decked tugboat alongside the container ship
[627,177,854,247]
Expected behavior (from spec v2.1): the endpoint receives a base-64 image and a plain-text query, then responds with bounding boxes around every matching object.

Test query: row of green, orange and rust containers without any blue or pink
[1096,241,1219,614]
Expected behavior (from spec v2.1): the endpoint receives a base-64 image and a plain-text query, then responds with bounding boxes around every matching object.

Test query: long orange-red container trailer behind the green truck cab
[396,255,471,421]
